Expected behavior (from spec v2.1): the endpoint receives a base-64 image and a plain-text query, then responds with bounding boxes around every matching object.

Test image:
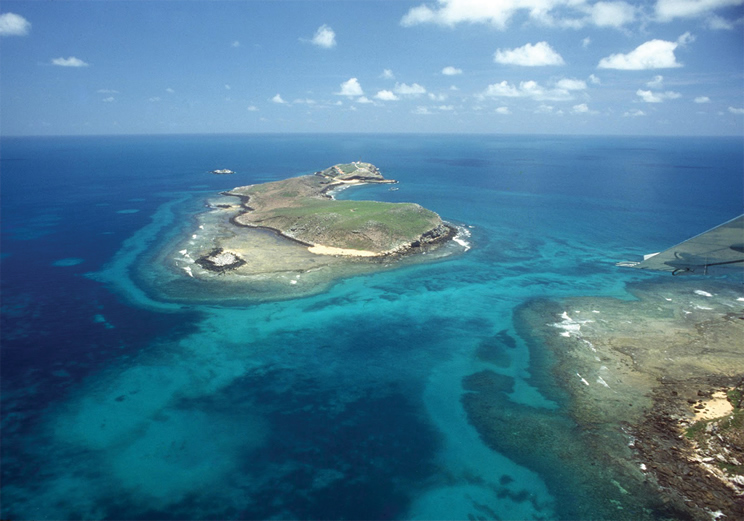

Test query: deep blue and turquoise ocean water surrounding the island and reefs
[0,135,744,520]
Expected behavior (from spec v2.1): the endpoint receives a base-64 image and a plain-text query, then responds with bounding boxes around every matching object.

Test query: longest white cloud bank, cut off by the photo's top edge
[401,0,636,30]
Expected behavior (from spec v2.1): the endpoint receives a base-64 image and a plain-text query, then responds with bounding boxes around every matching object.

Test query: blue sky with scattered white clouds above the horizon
[0,0,744,135]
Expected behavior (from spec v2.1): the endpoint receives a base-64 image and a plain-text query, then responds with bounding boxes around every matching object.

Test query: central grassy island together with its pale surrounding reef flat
[149,163,467,300]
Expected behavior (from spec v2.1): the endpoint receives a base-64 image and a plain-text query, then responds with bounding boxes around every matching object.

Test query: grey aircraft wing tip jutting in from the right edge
[618,215,744,275]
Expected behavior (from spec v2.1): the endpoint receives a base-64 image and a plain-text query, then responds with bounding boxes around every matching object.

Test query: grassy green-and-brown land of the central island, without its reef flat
[226,162,451,256]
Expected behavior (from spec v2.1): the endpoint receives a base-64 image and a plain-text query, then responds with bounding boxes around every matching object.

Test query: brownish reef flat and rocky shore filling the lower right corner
[463,277,744,521]
